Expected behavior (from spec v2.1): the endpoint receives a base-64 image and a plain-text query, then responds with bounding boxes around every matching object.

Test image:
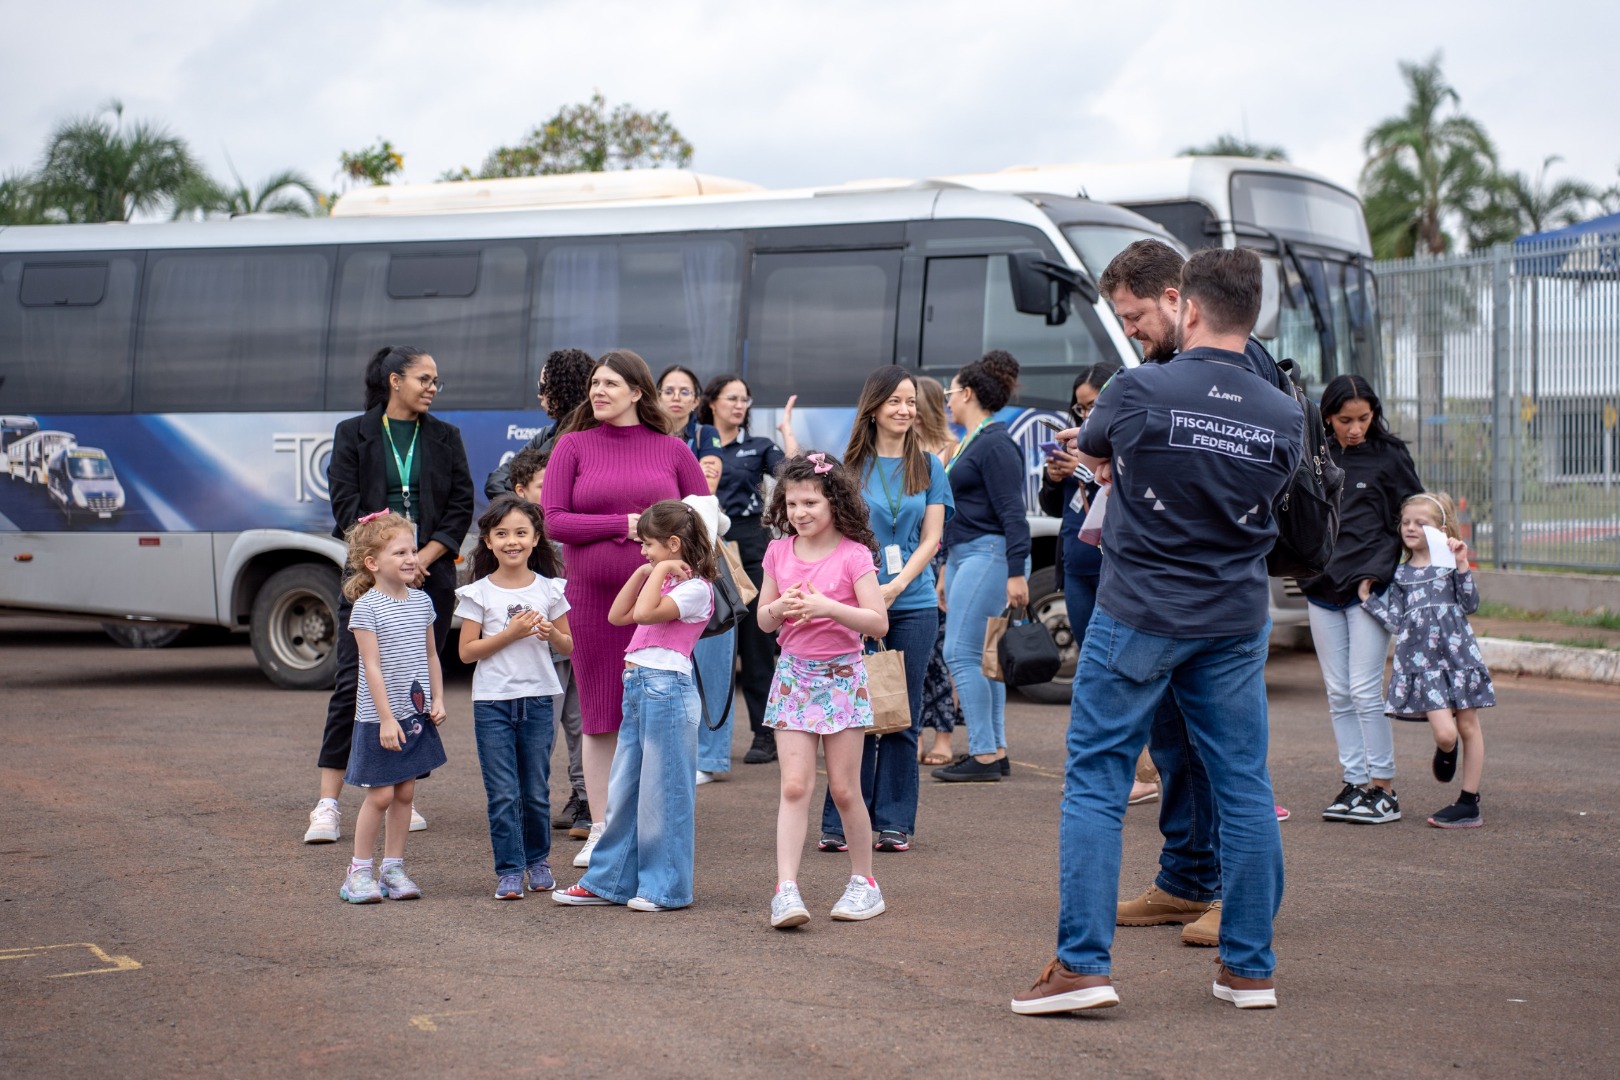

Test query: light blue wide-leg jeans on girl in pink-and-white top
[580,667,703,907]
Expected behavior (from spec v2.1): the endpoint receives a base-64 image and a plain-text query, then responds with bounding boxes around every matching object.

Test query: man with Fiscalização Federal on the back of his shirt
[1013,249,1304,1014]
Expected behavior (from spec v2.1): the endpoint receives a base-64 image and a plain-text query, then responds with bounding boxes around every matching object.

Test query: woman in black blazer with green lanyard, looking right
[305,345,473,844]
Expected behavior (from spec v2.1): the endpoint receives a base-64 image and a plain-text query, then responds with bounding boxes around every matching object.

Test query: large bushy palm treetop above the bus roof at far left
[39,100,201,222]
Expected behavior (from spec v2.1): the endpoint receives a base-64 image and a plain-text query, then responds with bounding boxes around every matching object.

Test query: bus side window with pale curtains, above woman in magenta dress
[530,236,742,379]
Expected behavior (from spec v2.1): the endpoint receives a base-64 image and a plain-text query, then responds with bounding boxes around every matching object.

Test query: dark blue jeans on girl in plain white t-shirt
[473,698,556,874]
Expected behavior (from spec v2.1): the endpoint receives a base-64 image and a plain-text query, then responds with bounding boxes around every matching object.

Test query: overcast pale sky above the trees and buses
[0,0,1620,210]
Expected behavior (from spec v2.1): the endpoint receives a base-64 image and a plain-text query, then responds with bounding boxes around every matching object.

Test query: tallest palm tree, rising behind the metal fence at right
[1361,53,1497,259]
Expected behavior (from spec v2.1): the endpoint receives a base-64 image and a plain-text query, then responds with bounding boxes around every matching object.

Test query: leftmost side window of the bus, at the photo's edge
[0,254,139,413]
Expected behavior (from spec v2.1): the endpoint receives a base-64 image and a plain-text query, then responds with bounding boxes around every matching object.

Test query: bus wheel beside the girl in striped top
[249,562,339,690]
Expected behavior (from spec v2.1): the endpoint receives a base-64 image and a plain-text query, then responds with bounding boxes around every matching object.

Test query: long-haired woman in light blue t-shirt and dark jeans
[818,366,956,852]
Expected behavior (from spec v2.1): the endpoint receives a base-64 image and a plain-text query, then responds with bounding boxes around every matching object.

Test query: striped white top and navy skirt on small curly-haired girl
[343,589,444,787]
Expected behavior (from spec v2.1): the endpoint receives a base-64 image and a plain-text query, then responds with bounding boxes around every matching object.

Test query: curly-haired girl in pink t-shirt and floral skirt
[760,453,889,929]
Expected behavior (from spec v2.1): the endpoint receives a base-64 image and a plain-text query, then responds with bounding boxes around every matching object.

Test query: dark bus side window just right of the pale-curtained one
[744,248,901,405]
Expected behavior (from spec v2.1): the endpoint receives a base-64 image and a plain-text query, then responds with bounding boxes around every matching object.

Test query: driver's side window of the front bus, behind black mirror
[922,254,1115,405]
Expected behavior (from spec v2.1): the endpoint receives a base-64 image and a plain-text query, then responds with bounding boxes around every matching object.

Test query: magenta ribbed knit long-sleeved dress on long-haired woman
[541,424,710,735]
